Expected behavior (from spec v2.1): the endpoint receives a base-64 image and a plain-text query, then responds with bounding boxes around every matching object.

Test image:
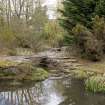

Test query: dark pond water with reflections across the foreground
[0,78,105,105]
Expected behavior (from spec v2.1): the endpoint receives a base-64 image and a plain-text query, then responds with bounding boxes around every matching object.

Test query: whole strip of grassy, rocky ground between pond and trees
[0,48,105,92]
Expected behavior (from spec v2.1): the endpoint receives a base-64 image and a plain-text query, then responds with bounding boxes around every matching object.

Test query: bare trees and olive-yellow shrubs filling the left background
[0,0,48,51]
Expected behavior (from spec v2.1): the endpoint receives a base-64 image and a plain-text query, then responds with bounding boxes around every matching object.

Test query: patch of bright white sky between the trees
[43,0,57,19]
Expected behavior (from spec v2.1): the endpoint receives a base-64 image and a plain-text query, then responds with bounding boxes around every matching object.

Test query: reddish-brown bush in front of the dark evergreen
[72,16,105,61]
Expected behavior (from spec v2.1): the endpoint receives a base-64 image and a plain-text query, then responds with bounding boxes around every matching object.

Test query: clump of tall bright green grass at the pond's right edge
[85,75,105,92]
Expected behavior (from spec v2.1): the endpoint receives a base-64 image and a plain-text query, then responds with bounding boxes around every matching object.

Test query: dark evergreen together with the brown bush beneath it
[60,0,105,57]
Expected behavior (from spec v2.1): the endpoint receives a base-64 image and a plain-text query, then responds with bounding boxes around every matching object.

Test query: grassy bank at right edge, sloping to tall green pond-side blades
[71,64,105,93]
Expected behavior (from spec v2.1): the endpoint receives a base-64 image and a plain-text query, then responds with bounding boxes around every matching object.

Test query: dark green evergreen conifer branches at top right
[60,0,105,32]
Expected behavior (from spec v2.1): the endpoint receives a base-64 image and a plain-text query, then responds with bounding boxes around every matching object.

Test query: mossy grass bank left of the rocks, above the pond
[0,61,48,82]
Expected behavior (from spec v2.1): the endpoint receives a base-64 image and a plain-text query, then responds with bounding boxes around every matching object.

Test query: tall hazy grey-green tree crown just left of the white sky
[30,4,48,32]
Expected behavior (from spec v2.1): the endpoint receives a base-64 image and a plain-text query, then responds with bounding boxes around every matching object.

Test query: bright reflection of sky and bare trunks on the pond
[0,80,64,105]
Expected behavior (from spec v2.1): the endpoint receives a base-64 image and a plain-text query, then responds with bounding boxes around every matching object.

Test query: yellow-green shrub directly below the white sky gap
[45,20,65,47]
